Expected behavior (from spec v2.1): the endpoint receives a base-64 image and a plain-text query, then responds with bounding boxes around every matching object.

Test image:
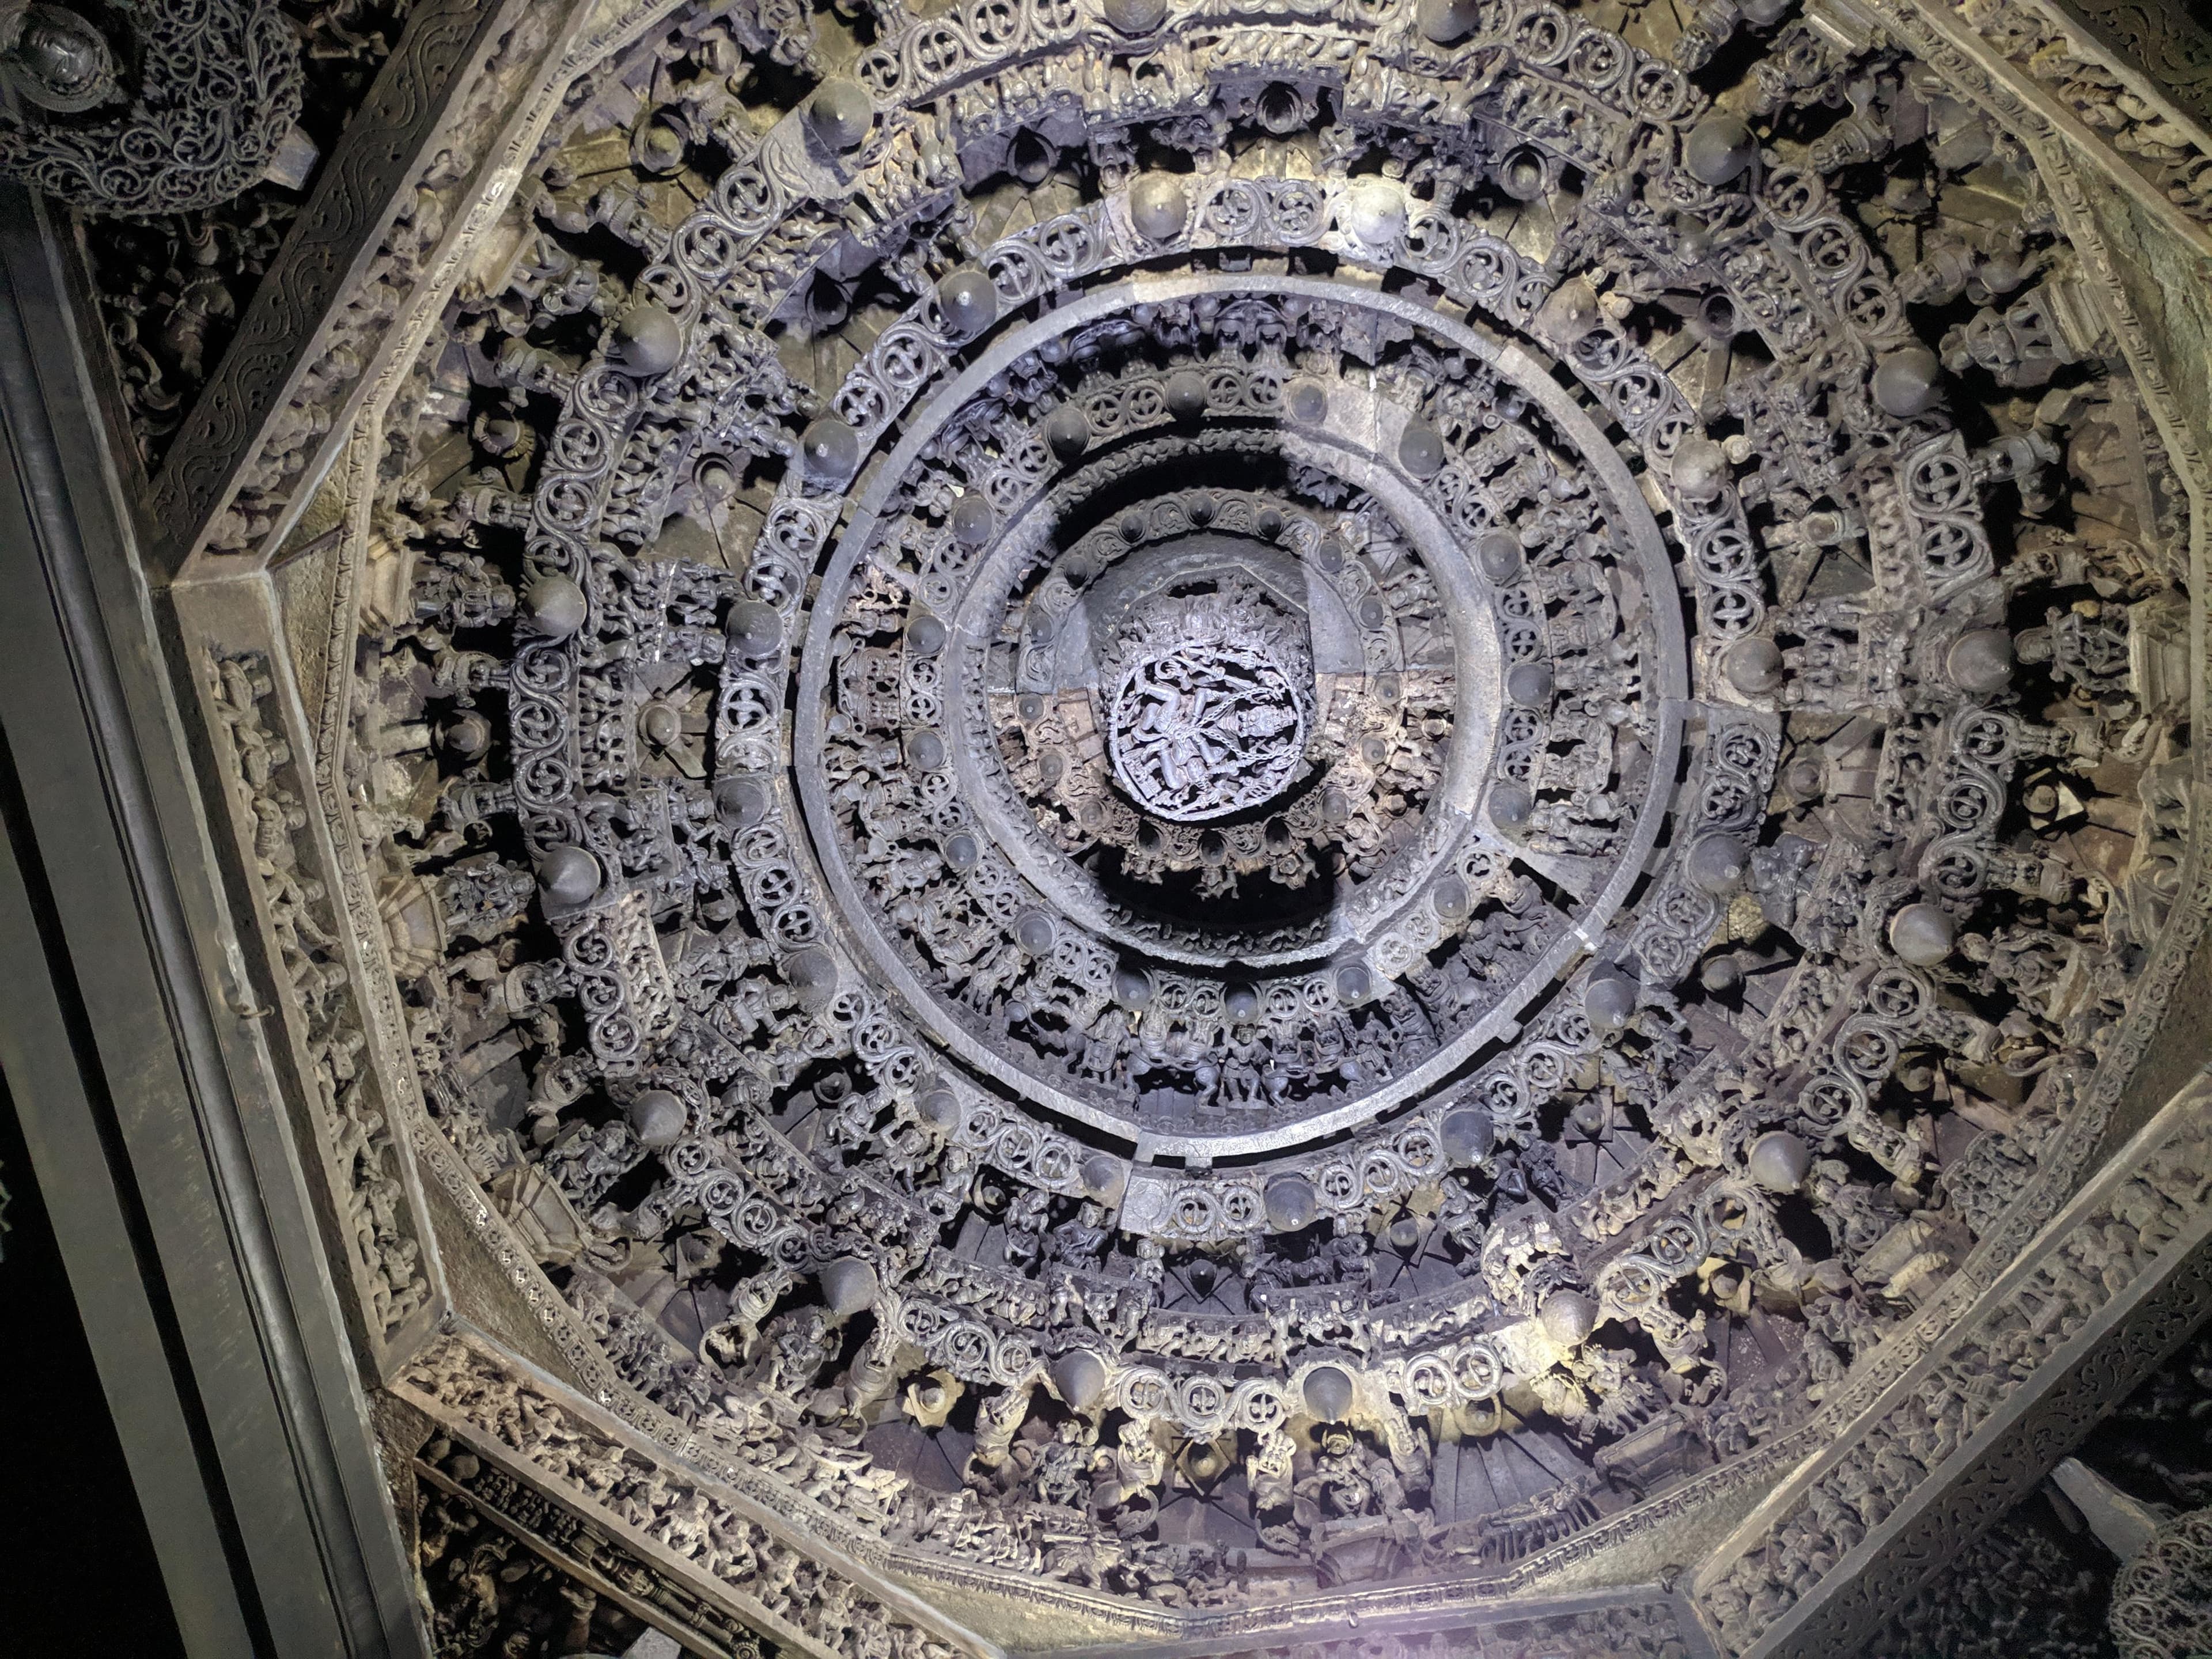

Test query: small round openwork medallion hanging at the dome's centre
[1106,628,1312,823]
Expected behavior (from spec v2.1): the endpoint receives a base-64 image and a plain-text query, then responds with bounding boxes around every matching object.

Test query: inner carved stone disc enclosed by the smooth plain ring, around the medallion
[794,279,1688,1150]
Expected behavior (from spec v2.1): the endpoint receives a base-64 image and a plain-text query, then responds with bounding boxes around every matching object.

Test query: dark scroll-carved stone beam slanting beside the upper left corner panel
[148,0,527,573]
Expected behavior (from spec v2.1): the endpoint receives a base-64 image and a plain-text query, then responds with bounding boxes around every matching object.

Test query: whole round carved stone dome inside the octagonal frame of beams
[354,0,2188,1635]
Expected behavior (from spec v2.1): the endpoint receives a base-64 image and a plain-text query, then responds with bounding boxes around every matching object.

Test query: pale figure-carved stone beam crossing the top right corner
[1866,0,2212,252]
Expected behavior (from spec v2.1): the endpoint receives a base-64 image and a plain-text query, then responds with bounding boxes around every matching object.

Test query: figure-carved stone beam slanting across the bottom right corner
[1694,1071,2212,1659]
